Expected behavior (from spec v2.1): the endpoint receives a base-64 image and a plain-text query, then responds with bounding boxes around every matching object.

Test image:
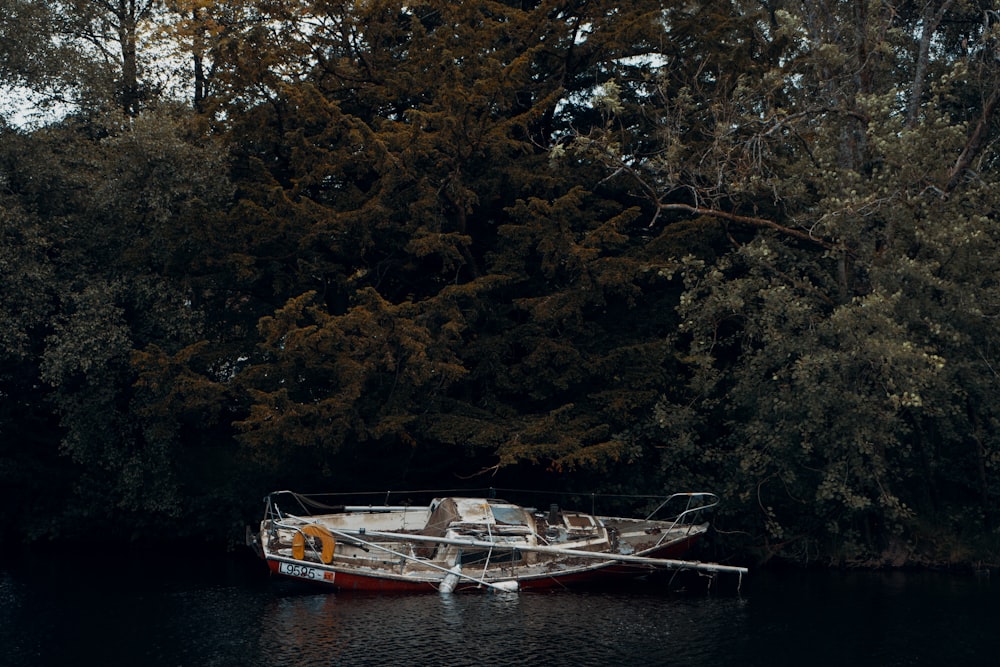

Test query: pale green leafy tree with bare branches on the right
[577,2,997,560]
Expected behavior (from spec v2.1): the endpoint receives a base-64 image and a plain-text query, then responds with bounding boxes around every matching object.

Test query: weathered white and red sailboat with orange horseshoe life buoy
[251,491,746,593]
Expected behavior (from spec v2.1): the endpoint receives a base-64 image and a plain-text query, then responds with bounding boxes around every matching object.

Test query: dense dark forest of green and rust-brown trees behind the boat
[0,0,1000,565]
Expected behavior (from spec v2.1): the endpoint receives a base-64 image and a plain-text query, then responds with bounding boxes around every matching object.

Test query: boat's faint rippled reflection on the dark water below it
[252,592,746,666]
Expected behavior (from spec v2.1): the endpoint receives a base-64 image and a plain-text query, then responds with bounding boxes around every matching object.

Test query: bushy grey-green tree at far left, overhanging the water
[2,105,238,534]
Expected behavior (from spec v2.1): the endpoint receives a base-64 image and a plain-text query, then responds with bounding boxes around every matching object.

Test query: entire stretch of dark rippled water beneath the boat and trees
[0,555,1000,667]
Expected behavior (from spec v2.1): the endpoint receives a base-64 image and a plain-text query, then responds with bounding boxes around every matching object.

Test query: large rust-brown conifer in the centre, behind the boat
[206,2,704,486]
